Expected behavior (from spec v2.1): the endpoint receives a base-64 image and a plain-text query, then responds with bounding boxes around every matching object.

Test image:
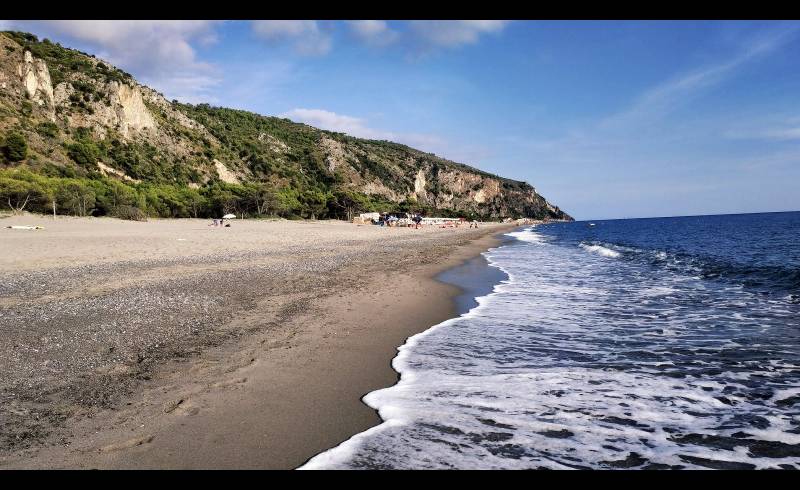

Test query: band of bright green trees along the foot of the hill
[0,164,418,219]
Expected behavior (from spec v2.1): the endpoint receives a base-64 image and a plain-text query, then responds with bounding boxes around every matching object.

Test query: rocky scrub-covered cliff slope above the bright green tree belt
[0,33,569,219]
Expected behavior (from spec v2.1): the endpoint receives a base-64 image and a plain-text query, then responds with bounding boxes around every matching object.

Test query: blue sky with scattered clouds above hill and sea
[0,20,800,219]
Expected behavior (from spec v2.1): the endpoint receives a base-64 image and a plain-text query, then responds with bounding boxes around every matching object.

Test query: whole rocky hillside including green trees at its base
[0,32,571,219]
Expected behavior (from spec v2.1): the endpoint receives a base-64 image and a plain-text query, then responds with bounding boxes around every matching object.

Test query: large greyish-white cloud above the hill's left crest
[3,20,220,100]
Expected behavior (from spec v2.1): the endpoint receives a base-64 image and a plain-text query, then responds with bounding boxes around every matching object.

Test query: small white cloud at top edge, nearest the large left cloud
[252,20,332,56]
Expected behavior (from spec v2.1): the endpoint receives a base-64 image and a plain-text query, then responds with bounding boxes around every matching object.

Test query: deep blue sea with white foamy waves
[303,212,800,469]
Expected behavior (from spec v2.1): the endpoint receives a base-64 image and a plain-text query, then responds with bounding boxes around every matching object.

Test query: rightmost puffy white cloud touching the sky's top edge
[410,20,508,48]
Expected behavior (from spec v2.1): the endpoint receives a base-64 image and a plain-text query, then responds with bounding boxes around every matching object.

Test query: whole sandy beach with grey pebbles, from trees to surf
[0,215,513,469]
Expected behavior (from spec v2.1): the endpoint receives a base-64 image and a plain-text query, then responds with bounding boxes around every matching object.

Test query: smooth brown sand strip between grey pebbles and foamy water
[0,216,516,469]
